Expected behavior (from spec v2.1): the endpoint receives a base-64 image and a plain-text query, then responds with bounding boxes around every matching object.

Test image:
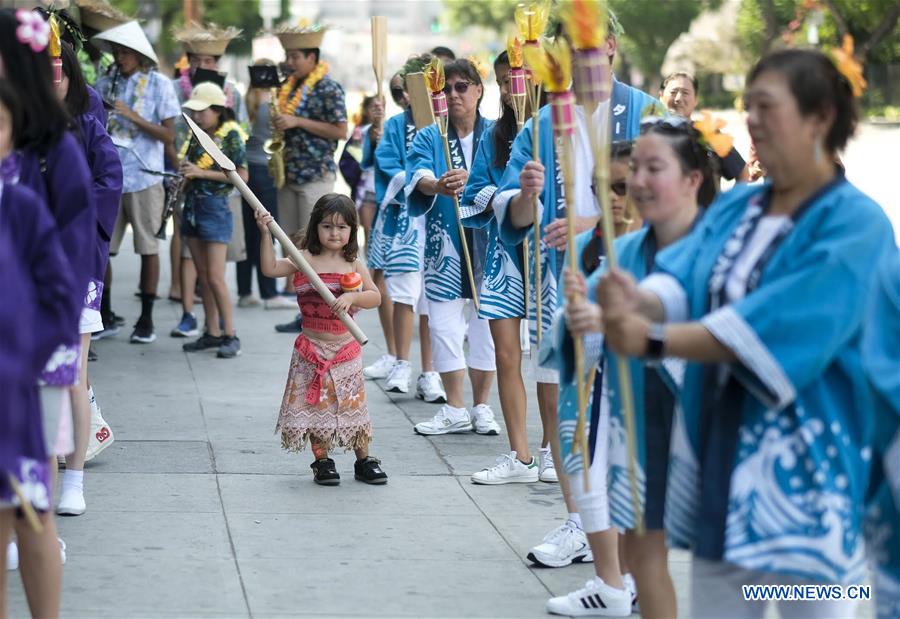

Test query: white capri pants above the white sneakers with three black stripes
[569,372,611,533]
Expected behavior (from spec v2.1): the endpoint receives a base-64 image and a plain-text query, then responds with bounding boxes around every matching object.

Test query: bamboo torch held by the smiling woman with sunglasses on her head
[525,39,590,489]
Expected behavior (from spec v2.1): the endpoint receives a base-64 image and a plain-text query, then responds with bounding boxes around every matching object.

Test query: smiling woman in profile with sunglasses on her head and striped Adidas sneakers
[548,124,715,617]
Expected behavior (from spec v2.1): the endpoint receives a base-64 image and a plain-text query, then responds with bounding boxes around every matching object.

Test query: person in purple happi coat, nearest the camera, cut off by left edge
[0,74,84,617]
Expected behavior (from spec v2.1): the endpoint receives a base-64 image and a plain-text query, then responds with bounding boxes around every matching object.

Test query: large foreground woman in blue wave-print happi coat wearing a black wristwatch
[599,50,896,617]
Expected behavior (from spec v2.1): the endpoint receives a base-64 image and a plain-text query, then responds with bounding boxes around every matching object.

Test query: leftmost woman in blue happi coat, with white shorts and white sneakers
[363,54,446,402]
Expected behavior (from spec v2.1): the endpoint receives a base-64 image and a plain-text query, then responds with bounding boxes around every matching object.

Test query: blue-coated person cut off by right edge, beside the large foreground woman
[863,252,900,619]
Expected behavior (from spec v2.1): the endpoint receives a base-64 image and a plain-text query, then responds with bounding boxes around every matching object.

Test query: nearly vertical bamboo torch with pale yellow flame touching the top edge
[515,2,550,347]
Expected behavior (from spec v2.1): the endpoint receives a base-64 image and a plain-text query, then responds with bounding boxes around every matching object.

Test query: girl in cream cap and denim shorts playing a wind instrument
[180,82,248,359]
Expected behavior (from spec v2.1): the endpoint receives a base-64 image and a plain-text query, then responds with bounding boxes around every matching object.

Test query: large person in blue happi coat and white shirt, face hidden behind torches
[492,18,661,567]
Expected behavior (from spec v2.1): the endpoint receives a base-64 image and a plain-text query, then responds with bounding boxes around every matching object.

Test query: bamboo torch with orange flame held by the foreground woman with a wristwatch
[563,0,644,534]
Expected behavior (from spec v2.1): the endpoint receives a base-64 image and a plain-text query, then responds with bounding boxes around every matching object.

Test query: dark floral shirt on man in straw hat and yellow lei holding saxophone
[284,76,347,185]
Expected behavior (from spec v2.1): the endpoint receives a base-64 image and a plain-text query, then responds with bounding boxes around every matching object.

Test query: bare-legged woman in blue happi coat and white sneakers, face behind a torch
[461,51,546,485]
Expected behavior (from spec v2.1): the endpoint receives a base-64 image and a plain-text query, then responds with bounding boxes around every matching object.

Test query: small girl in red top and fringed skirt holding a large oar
[256,193,387,486]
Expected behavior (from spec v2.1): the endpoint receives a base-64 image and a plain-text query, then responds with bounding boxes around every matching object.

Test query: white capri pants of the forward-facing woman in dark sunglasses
[428,299,497,373]
